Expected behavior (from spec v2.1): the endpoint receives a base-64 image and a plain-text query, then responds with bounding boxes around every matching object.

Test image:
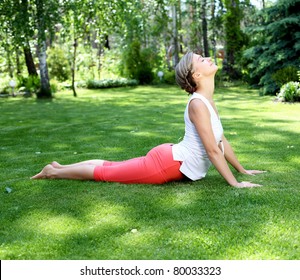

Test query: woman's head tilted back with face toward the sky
[175,52,218,93]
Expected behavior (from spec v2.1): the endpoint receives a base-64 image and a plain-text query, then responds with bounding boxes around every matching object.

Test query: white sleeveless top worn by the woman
[172,92,224,181]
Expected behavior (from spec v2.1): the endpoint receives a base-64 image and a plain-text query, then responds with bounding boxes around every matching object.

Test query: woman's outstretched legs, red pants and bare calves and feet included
[31,144,183,184]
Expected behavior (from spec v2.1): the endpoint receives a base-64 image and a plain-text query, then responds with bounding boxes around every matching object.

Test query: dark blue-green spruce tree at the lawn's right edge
[243,0,300,94]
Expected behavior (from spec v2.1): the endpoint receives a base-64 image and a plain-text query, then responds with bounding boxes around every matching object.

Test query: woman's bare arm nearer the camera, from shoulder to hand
[189,99,260,187]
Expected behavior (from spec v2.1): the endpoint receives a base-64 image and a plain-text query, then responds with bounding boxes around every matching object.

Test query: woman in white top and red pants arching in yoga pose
[32,52,263,187]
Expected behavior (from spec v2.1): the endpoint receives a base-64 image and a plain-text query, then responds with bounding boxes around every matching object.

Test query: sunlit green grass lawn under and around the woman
[0,87,300,260]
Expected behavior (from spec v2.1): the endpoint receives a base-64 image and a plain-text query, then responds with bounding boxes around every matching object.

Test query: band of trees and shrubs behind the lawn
[0,0,300,98]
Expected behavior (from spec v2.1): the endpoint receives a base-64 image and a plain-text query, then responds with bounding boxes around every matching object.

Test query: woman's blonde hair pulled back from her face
[175,51,196,94]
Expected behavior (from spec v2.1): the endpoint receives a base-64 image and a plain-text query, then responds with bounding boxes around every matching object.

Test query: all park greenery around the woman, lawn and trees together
[0,0,300,260]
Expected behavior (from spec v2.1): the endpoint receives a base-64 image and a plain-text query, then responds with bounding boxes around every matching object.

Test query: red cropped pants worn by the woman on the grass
[94,144,184,184]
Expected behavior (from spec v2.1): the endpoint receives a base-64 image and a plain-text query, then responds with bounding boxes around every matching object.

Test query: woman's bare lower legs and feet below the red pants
[31,164,95,180]
